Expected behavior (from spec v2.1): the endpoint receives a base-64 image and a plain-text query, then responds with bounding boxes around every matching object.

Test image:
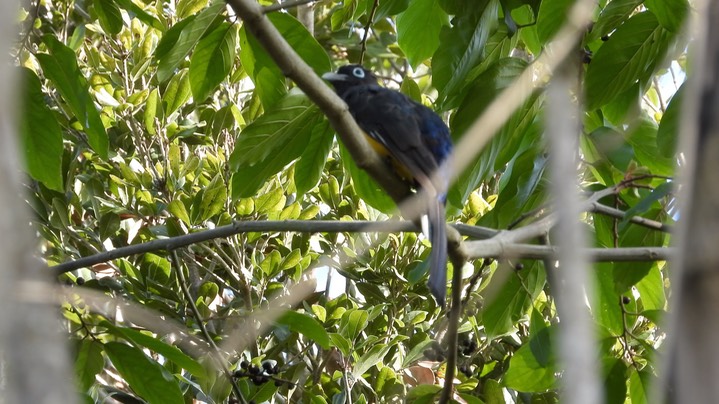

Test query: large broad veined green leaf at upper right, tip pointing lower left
[585,12,672,110]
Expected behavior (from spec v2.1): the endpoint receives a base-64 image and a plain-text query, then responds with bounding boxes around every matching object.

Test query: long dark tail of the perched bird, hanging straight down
[427,197,447,307]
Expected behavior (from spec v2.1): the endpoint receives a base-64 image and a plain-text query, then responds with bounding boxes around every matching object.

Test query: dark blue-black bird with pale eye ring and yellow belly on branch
[322,65,452,306]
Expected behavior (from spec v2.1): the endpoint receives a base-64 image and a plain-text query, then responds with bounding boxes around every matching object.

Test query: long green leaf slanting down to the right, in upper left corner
[35,35,109,159]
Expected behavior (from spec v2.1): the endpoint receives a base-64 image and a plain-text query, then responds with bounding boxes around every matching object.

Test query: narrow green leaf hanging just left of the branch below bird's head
[295,119,334,195]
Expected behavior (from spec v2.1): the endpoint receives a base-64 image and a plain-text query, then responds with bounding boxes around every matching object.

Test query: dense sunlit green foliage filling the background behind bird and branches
[14,0,689,403]
